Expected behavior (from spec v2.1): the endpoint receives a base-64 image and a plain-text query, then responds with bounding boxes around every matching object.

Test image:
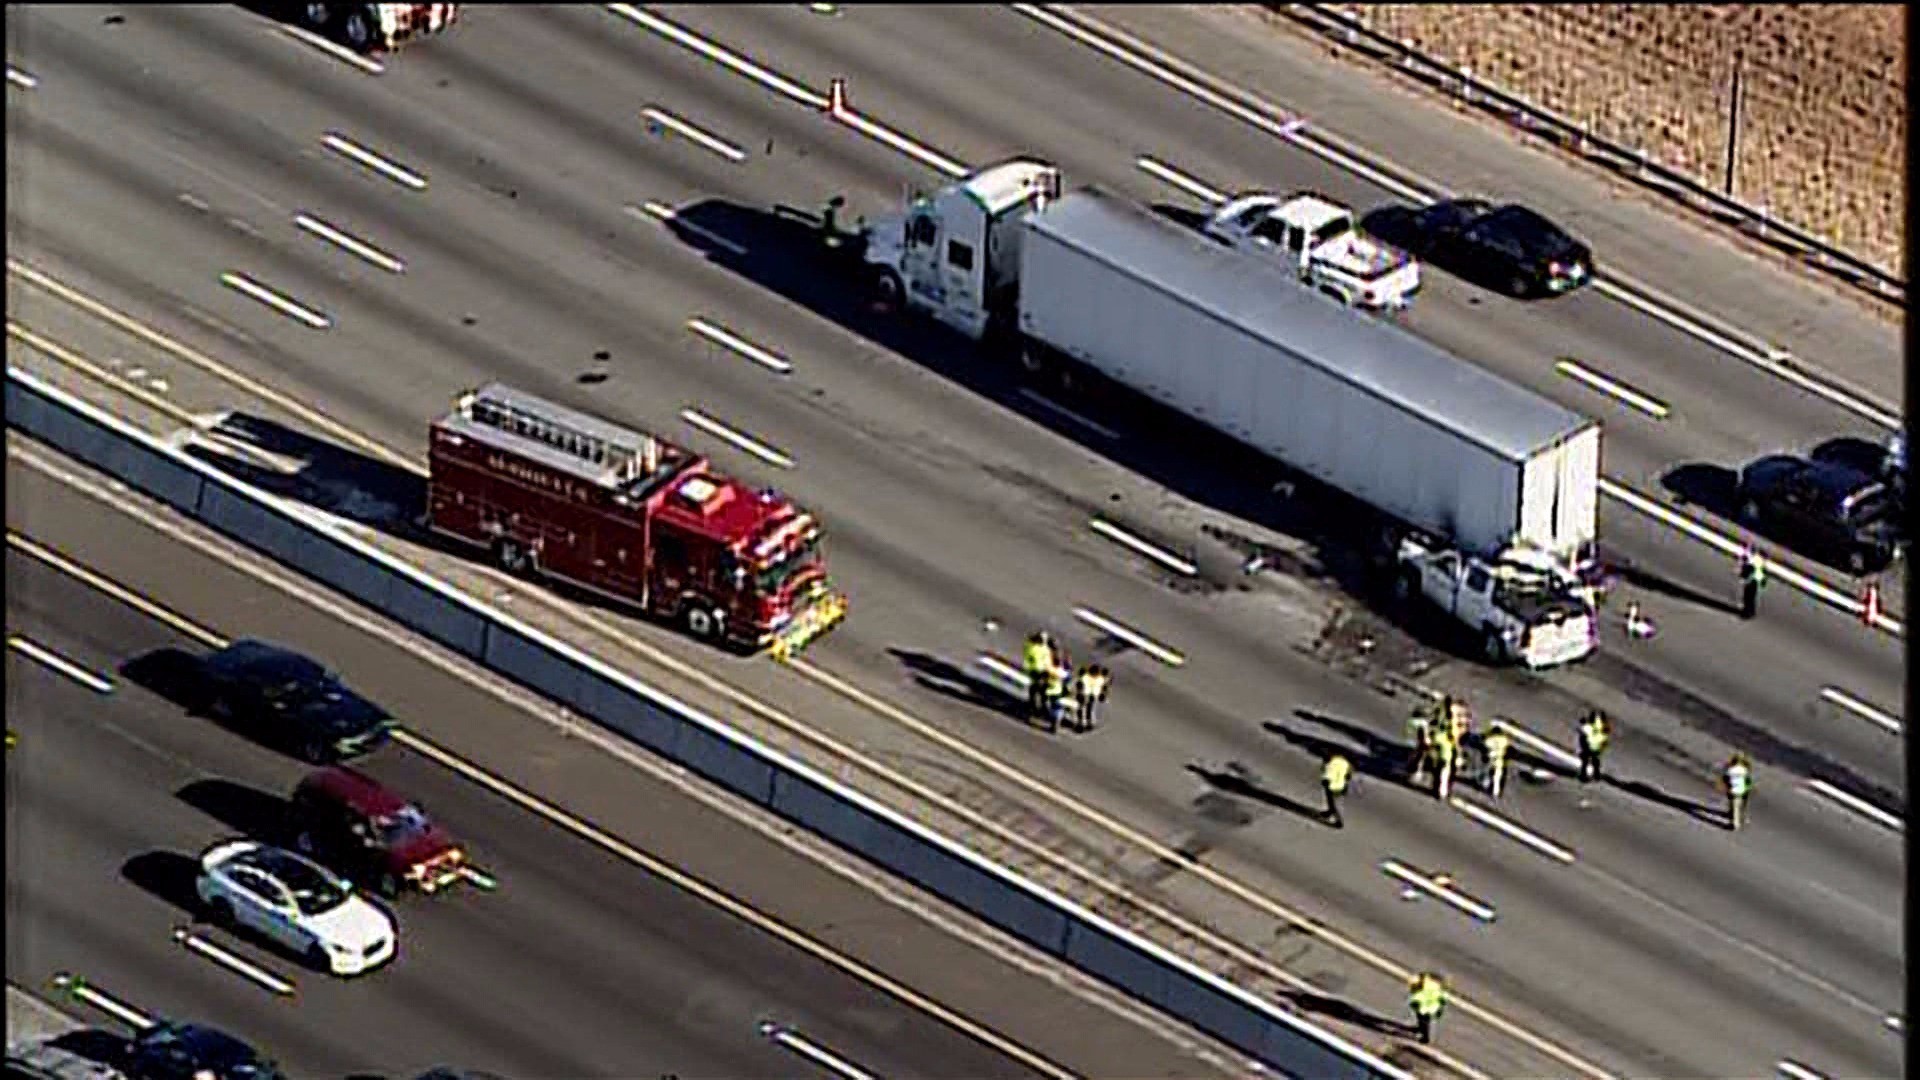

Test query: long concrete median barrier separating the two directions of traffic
[6,369,1413,1080]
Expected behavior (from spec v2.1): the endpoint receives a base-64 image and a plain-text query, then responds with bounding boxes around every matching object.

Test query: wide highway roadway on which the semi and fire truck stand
[8,6,1905,1074]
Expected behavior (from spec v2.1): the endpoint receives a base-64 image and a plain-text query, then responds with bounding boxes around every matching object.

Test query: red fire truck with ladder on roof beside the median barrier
[426,382,847,657]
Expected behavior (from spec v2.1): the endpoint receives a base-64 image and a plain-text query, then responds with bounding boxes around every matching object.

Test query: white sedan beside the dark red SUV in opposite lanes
[194,840,399,976]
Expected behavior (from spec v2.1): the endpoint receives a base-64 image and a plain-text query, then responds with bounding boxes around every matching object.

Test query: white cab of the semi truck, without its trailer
[864,160,1060,340]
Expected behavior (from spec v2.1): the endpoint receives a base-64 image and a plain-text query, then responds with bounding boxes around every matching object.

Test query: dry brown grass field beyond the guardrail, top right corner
[1344,4,1907,273]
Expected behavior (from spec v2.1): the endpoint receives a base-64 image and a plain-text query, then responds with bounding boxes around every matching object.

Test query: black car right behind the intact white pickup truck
[1407,198,1594,298]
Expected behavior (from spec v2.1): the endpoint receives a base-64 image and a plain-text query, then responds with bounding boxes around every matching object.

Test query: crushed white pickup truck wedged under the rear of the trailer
[1394,536,1599,671]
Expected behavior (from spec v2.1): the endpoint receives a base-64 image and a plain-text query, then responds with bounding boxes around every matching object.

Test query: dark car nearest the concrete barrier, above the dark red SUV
[204,642,394,765]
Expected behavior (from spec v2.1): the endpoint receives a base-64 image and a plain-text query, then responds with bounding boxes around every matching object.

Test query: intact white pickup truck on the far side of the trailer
[1202,192,1421,309]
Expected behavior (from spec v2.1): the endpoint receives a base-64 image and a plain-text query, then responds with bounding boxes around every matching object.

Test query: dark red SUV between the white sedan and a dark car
[292,765,467,897]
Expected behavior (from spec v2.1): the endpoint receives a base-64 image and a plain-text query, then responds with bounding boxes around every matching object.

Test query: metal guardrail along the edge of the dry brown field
[1267,4,1907,307]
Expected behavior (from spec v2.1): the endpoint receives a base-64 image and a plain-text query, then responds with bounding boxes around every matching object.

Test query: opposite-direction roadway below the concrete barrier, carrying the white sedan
[8,467,1215,1080]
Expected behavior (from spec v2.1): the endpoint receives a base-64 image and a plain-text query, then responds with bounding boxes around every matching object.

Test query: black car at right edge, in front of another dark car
[1740,455,1897,575]
